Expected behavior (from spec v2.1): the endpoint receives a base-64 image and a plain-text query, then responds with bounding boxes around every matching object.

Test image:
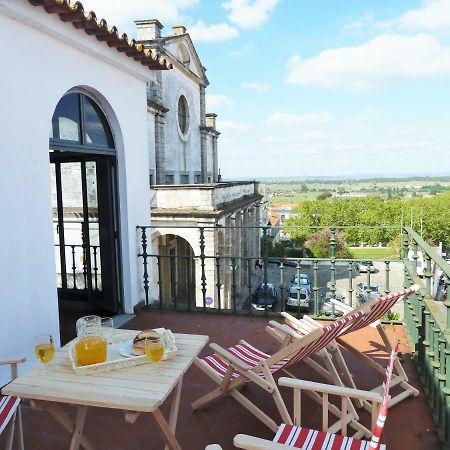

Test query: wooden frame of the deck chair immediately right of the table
[192,305,370,435]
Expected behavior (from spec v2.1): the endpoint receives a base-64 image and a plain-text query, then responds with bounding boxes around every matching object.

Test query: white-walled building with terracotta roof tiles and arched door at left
[0,0,171,384]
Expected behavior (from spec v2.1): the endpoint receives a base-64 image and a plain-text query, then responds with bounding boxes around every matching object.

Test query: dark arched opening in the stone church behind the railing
[157,234,195,310]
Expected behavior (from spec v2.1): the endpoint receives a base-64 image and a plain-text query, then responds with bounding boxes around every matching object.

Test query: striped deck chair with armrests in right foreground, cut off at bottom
[230,342,398,450]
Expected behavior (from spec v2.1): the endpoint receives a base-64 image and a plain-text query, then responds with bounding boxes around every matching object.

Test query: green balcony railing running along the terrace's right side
[403,228,450,449]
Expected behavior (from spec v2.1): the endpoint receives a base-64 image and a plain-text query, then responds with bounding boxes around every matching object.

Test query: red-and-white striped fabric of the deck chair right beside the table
[203,312,362,379]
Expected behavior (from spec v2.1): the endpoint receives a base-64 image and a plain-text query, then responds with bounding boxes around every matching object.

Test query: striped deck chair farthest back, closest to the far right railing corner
[267,285,419,410]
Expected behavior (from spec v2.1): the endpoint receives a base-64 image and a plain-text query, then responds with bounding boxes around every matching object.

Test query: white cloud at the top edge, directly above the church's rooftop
[78,0,199,29]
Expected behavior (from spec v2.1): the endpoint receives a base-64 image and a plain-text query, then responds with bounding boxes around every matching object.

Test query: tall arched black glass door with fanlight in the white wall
[49,92,121,313]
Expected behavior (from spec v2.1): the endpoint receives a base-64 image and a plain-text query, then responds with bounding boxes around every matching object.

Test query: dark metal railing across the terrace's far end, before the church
[138,225,403,317]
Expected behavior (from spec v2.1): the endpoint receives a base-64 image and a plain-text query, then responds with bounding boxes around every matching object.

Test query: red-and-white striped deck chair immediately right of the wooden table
[192,307,368,433]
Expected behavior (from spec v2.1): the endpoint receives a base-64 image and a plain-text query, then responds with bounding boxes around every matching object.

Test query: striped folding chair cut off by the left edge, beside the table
[0,358,25,450]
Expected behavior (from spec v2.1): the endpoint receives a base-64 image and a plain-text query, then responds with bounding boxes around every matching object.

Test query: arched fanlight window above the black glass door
[50,93,114,153]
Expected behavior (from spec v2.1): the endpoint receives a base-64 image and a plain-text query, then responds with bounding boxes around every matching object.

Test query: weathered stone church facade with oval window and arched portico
[136,19,263,308]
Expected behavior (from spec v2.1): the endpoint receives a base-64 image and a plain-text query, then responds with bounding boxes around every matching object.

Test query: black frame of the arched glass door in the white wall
[49,91,123,313]
